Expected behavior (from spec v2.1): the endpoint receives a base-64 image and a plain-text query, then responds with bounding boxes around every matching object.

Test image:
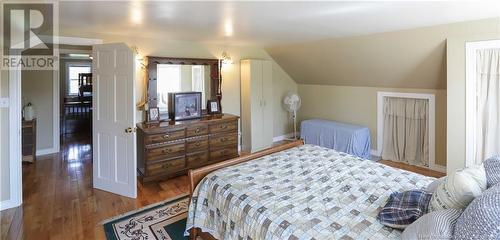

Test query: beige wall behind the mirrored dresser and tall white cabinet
[62,34,297,139]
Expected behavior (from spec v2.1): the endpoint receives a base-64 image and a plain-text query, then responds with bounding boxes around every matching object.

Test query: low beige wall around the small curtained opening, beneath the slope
[299,84,446,166]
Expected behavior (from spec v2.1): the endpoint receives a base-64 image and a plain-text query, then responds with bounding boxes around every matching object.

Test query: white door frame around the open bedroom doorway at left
[0,36,103,210]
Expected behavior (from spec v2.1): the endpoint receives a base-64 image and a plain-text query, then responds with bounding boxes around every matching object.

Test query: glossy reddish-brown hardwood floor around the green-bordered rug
[0,135,443,240]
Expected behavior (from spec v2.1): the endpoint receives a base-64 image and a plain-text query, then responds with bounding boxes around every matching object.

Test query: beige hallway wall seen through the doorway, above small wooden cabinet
[21,70,54,150]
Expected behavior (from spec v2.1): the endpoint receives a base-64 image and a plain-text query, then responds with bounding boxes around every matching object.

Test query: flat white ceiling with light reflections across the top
[59,1,500,46]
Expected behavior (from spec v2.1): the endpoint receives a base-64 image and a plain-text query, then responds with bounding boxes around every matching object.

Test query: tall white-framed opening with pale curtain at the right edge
[465,40,500,167]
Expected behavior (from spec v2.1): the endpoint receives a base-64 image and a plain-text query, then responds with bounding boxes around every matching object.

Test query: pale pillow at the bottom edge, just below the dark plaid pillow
[401,209,462,240]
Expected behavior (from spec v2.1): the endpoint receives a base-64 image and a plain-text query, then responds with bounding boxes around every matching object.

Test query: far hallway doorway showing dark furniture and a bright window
[59,51,93,170]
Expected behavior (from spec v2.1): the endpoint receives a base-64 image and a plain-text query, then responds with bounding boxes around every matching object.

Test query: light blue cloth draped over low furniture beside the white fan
[300,119,371,159]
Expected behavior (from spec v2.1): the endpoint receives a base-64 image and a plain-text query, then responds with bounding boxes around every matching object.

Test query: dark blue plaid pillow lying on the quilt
[377,190,432,229]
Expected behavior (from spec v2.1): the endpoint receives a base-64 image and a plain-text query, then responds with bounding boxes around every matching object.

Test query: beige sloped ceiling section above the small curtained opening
[266,18,500,89]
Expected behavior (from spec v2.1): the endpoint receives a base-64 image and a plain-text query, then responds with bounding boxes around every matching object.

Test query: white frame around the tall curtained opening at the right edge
[465,40,500,167]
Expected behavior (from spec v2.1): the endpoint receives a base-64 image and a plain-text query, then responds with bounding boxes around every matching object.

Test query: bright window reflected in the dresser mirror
[156,64,181,112]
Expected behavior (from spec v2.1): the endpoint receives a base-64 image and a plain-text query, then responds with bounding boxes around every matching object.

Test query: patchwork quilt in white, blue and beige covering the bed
[185,145,434,240]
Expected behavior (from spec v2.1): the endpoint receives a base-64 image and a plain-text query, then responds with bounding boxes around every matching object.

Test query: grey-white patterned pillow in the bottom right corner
[453,184,500,240]
